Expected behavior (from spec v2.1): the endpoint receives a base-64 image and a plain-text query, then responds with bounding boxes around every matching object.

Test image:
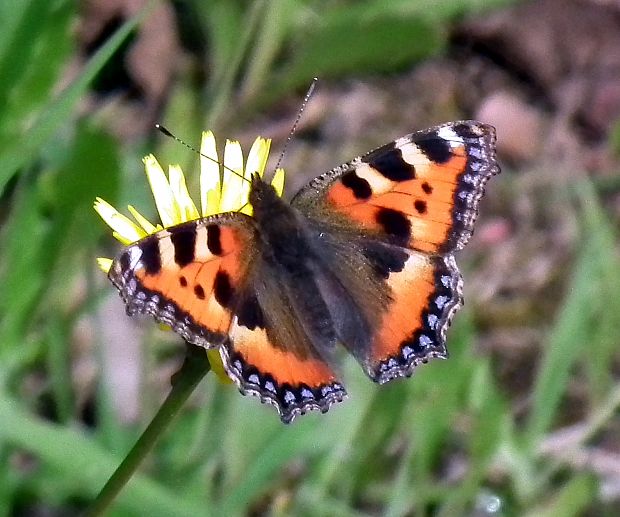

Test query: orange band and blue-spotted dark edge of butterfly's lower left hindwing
[220,324,346,423]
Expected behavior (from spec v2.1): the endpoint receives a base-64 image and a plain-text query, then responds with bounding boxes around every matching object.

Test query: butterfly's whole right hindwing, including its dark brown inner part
[298,227,462,384]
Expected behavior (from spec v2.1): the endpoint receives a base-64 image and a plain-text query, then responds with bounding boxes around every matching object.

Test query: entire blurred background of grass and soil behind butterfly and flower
[0,0,620,516]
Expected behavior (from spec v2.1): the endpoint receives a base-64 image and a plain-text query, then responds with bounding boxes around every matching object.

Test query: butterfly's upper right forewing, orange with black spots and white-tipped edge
[292,117,499,254]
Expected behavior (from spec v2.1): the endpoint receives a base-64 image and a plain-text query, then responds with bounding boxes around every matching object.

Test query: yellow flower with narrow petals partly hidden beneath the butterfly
[94,131,284,382]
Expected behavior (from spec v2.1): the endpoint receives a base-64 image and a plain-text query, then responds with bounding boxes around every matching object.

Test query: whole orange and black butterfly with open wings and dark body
[109,121,499,423]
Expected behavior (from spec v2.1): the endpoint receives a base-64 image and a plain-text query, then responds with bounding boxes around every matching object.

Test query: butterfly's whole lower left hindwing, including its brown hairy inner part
[220,266,347,423]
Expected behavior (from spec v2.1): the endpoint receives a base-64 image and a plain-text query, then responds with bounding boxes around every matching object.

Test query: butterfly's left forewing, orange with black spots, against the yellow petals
[109,216,255,348]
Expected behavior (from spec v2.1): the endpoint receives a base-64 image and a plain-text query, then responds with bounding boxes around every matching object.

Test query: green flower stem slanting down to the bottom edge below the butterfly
[87,344,211,517]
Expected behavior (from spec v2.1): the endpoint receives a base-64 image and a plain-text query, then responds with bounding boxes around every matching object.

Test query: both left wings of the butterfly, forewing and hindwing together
[109,213,346,423]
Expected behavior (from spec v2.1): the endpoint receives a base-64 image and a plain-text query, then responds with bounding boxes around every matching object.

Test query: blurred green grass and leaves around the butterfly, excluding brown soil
[0,0,620,517]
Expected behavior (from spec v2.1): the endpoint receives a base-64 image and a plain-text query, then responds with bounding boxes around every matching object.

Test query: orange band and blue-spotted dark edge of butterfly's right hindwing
[366,252,462,384]
